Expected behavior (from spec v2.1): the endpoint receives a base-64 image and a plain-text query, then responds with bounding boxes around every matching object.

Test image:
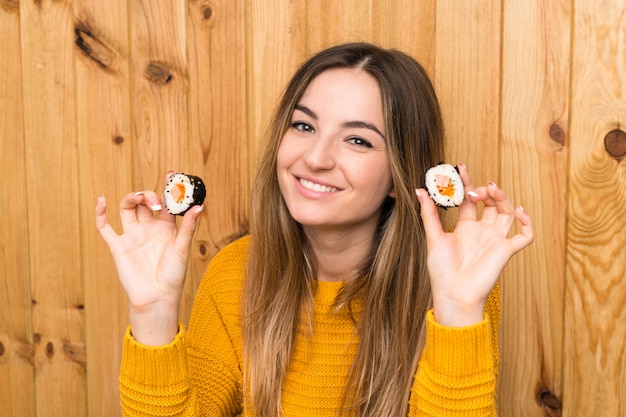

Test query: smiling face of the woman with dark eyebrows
[277,68,392,231]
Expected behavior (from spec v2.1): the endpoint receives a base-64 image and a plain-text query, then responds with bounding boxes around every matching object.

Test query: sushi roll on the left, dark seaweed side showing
[163,173,206,216]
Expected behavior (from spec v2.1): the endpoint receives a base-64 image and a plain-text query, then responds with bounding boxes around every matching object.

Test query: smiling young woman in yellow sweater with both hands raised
[96,43,533,417]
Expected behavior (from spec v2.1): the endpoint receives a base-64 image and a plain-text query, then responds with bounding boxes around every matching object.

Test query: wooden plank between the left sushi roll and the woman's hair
[185,0,250,315]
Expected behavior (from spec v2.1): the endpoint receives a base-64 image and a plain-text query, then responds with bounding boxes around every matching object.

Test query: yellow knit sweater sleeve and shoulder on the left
[120,237,246,417]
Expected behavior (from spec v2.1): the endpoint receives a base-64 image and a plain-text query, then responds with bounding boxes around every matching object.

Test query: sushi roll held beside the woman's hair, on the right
[425,164,465,209]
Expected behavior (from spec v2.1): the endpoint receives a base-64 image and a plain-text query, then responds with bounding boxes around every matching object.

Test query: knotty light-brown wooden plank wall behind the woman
[0,0,626,417]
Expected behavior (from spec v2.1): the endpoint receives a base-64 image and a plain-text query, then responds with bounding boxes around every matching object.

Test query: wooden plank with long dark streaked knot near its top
[73,0,133,417]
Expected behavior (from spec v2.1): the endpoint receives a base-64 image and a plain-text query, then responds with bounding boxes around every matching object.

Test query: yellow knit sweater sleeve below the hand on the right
[409,286,500,417]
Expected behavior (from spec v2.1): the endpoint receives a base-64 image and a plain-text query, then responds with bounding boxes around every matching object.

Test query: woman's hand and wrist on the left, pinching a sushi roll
[95,172,203,346]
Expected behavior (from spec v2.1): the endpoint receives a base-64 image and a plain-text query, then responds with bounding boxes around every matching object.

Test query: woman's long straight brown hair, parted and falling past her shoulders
[243,43,444,417]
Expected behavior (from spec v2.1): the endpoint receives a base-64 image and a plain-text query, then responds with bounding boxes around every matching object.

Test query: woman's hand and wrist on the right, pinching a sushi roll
[417,164,533,327]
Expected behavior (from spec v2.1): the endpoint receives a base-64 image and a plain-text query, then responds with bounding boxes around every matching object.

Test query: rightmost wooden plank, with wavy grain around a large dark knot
[563,0,626,416]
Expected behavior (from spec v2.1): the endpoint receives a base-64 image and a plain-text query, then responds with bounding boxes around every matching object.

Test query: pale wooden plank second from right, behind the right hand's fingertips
[499,1,571,417]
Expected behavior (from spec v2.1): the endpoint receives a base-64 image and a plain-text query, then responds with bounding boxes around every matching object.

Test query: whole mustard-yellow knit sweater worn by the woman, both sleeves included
[120,238,499,417]
